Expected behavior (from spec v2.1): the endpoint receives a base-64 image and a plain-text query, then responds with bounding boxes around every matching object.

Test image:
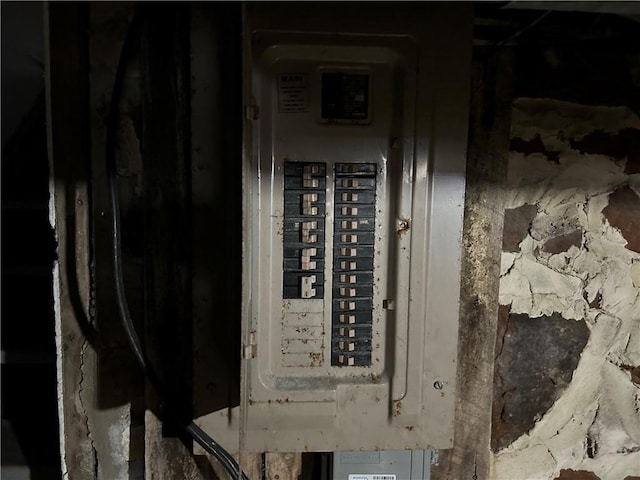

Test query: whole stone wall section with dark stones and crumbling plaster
[492,98,640,480]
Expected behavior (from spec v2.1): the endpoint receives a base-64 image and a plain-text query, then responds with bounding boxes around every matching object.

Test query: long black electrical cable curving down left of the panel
[106,9,249,480]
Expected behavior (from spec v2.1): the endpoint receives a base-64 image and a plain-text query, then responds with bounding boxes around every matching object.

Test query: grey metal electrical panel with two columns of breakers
[197,4,471,452]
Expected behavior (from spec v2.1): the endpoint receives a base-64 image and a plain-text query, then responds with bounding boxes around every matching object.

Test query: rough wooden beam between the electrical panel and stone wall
[431,48,513,480]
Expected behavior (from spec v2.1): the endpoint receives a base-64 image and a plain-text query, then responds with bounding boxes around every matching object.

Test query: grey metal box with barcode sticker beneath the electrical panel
[333,450,432,480]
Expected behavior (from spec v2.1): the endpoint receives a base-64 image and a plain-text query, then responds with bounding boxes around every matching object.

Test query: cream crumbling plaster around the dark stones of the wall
[492,98,640,480]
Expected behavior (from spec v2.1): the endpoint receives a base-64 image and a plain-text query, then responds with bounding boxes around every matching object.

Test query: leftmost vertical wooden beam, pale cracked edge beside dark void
[45,3,97,479]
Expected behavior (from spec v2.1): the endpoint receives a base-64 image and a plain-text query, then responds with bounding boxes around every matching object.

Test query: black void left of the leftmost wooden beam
[0,2,61,480]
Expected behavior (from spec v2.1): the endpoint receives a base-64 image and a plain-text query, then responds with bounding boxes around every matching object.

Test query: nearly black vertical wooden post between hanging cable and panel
[139,4,205,479]
